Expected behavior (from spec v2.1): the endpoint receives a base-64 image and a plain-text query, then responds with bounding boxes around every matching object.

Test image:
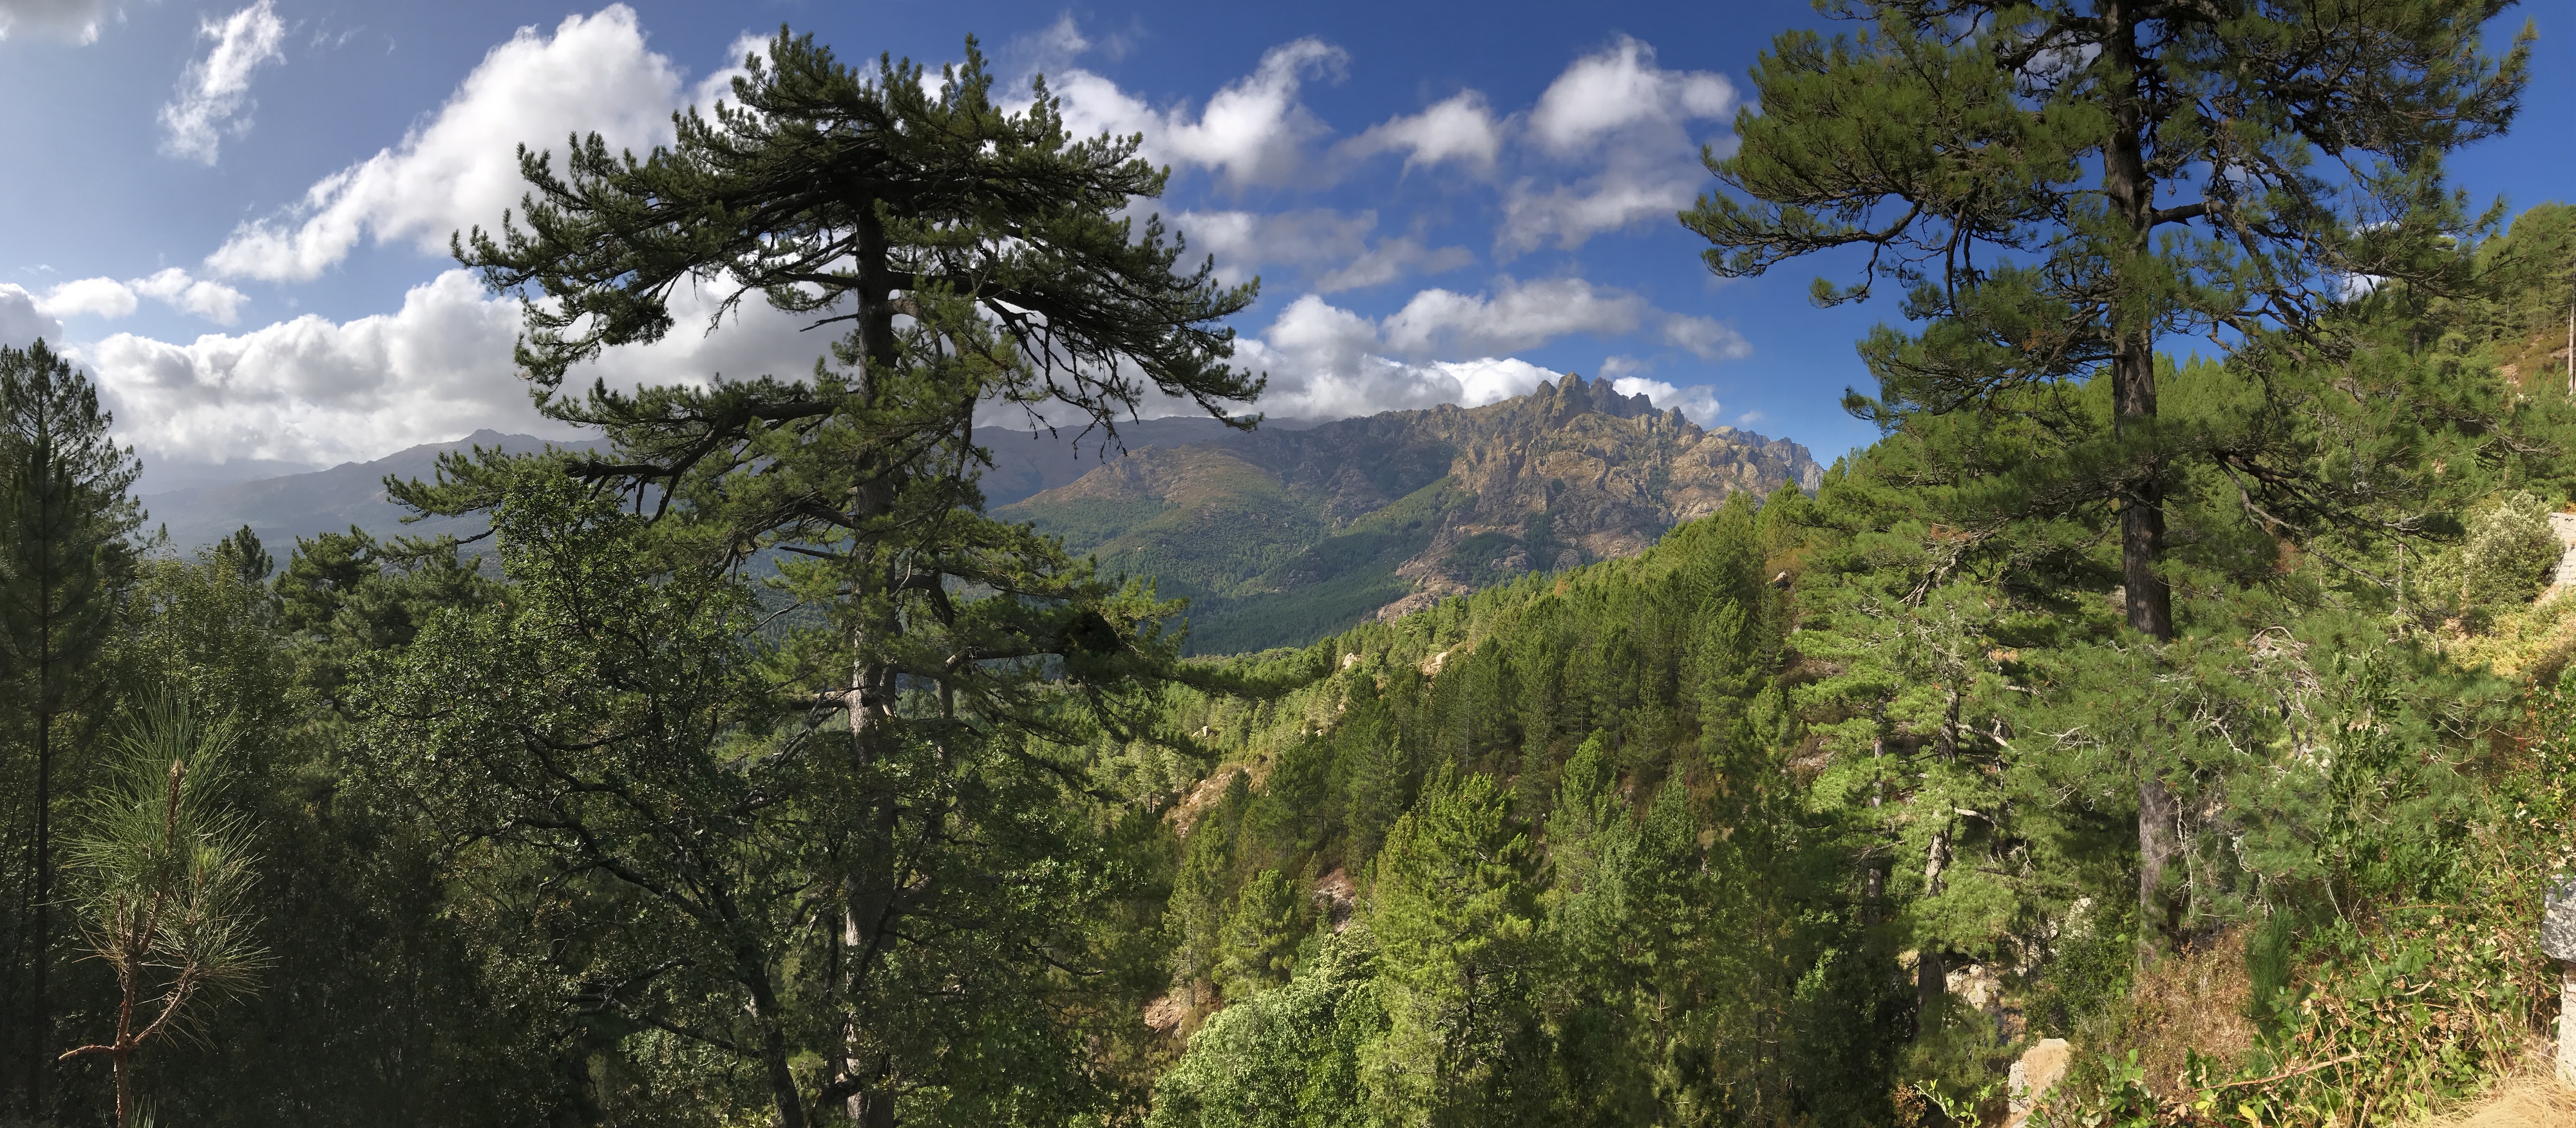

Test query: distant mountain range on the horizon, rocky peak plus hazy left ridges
[142,376,1824,654]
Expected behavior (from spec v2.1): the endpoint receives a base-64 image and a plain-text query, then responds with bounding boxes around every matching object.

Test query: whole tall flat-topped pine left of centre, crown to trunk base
[394,31,1260,1125]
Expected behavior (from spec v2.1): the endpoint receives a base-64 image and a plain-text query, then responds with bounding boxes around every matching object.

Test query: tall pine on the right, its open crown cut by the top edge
[1682,0,2527,958]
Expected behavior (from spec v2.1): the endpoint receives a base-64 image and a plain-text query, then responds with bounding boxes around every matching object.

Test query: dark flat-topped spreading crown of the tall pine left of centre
[456,31,1262,515]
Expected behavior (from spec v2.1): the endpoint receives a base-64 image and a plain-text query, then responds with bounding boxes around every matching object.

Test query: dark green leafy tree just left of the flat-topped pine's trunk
[353,484,809,1115]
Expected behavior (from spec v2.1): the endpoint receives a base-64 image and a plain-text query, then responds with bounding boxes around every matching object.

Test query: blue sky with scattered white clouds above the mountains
[0,0,2576,489]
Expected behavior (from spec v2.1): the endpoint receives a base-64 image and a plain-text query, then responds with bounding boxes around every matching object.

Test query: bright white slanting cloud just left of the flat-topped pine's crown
[206,5,685,281]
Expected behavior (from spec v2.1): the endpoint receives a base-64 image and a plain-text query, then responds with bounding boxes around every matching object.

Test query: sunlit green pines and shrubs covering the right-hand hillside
[1149,176,2561,1125]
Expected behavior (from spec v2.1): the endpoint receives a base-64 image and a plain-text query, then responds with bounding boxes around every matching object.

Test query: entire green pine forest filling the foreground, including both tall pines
[0,0,2576,1128]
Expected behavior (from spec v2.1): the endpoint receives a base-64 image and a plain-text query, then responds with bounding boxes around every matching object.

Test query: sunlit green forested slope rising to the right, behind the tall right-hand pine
[1149,206,2576,1125]
